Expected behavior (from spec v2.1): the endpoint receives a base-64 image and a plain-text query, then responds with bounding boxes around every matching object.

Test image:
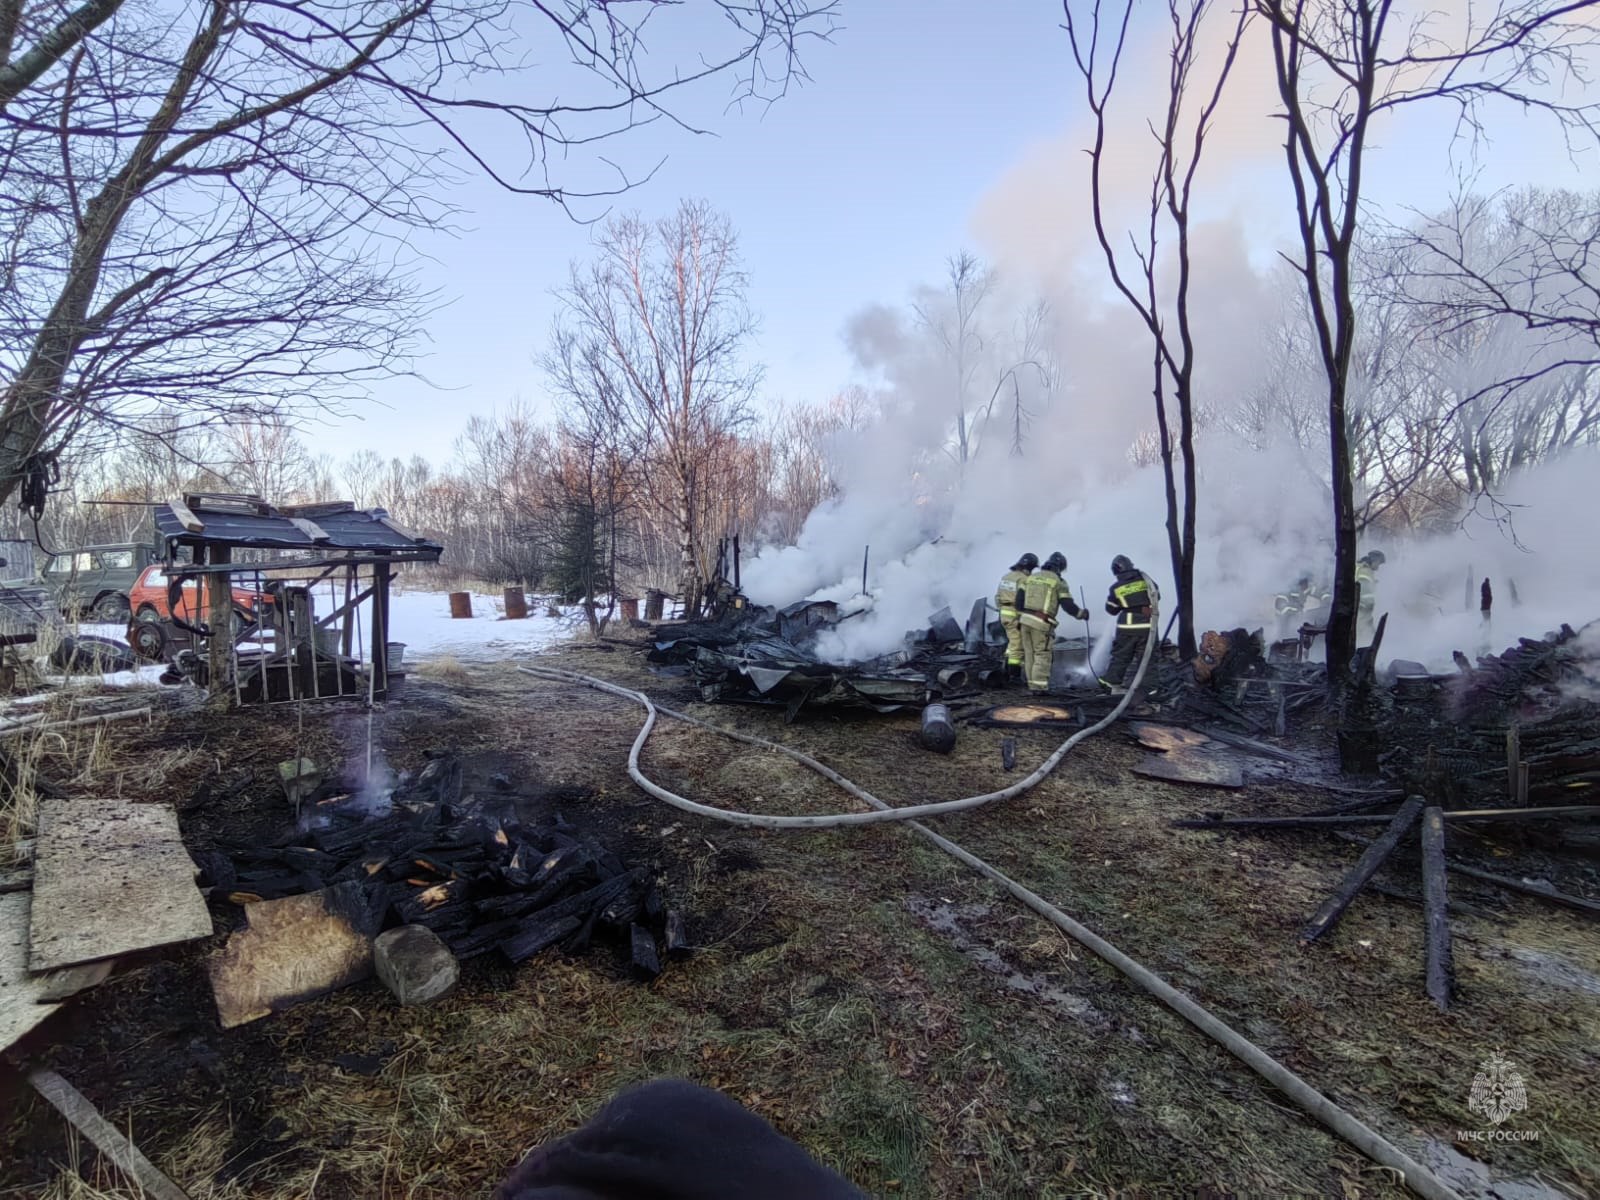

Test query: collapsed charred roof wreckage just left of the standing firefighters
[650,600,1000,722]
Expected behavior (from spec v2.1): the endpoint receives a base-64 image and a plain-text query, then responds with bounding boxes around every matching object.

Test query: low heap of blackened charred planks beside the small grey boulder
[200,755,686,978]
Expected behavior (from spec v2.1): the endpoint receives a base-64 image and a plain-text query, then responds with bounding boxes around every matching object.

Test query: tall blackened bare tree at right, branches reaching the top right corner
[1256,0,1597,693]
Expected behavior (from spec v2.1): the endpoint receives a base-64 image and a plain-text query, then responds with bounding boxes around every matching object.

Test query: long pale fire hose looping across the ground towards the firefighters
[517,608,1462,1200]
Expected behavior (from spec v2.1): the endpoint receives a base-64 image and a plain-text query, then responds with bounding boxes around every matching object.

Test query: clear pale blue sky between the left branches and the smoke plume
[310,0,1578,462]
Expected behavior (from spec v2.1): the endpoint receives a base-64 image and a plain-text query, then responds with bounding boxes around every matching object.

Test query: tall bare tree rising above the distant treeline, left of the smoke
[546,202,760,613]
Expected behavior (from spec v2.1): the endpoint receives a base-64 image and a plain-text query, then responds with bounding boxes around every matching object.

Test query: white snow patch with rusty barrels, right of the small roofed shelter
[389,589,589,666]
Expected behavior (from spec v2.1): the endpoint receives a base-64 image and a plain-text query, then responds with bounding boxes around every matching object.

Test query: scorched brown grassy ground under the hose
[0,633,1600,1200]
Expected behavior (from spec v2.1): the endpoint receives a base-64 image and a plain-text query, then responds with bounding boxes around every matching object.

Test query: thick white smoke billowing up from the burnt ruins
[744,0,1600,670]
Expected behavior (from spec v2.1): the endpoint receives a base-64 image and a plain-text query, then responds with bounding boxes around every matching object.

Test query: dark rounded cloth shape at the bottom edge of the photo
[493,1078,866,1200]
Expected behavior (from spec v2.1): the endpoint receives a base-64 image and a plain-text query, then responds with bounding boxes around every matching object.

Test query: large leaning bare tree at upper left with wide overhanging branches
[0,0,832,518]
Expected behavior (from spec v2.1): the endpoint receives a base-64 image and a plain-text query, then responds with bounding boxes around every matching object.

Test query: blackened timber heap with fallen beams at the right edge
[1174,622,1600,1011]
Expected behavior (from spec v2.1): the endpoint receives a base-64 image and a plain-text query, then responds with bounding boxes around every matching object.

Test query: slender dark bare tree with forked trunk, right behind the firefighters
[1062,0,1250,658]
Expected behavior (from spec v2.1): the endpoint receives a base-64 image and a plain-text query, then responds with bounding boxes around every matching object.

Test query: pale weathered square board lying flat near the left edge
[27,800,211,971]
